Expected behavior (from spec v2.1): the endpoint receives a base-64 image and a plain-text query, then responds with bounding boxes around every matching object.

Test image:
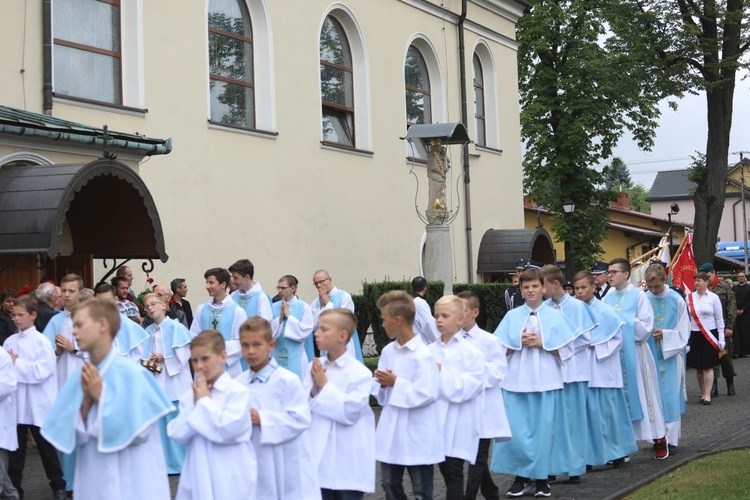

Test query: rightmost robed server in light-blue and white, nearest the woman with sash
[644,264,690,451]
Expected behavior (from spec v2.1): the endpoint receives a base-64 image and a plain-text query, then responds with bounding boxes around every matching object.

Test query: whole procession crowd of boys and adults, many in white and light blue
[0,259,750,500]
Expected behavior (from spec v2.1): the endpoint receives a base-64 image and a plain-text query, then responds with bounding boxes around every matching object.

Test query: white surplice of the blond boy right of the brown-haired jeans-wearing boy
[427,330,485,464]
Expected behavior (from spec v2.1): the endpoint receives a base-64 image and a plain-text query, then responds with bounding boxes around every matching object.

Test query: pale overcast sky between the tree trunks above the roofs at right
[613,78,750,189]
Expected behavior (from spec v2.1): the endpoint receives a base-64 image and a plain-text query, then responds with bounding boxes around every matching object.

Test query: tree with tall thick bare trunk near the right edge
[607,0,750,262]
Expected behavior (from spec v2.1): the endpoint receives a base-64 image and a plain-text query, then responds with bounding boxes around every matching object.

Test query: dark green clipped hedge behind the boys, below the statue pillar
[352,281,512,352]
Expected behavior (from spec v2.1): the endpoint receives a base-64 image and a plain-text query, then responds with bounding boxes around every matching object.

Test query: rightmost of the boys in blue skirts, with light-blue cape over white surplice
[573,271,638,468]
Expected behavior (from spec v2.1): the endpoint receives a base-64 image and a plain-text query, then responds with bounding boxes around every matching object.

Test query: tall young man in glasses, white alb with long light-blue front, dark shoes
[602,258,669,460]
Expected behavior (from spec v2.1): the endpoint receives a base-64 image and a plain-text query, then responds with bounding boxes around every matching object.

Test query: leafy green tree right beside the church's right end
[517,0,663,268]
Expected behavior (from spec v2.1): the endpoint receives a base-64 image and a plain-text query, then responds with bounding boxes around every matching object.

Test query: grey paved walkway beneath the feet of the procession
[16,358,750,500]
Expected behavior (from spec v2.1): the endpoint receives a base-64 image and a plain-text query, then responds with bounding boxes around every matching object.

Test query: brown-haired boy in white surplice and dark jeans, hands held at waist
[372,291,445,500]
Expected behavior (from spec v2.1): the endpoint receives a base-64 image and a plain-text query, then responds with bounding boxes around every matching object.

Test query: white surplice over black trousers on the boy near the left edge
[3,326,57,427]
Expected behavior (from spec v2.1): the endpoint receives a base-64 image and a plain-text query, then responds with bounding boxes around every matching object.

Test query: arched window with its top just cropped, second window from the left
[208,0,255,129]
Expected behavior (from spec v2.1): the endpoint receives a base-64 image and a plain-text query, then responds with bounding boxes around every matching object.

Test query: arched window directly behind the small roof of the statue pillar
[404,45,432,158]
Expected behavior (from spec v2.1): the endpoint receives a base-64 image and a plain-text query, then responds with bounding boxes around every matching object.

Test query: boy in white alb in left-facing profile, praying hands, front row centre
[302,308,375,500]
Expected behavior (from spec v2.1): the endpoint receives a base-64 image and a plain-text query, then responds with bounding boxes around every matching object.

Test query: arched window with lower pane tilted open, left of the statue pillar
[320,16,355,147]
